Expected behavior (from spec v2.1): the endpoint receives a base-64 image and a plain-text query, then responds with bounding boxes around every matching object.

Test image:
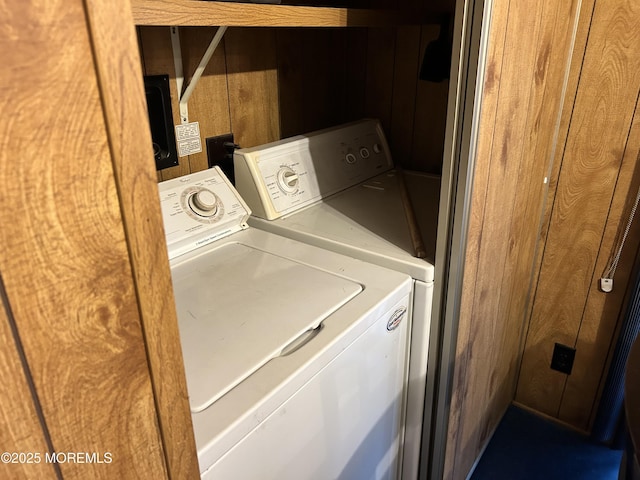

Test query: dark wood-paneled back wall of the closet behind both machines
[138,21,448,180]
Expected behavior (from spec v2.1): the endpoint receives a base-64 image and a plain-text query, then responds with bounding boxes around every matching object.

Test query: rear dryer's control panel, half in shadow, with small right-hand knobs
[234,120,393,220]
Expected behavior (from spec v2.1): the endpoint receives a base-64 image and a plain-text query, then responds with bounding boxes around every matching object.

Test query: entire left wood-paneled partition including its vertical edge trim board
[0,0,199,479]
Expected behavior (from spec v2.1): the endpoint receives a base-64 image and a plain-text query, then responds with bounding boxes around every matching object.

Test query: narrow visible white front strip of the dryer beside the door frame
[402,281,433,478]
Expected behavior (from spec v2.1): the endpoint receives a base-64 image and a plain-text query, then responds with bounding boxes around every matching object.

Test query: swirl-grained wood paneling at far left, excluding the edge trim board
[0,0,167,479]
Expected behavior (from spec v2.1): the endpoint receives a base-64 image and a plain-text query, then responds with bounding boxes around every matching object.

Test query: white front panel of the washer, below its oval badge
[202,297,410,480]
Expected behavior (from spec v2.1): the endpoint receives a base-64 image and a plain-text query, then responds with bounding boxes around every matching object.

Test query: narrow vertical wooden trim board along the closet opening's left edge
[85,0,200,478]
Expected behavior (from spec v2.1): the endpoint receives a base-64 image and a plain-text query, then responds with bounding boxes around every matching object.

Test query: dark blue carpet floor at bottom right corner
[471,407,622,480]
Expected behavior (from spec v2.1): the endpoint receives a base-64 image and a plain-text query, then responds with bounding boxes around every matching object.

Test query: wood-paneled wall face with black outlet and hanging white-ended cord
[516,0,640,431]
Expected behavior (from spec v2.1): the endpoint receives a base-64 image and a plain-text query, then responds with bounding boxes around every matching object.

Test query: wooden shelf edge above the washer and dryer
[131,0,429,27]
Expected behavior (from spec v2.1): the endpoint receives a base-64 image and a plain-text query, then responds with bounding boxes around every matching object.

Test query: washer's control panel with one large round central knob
[158,167,251,259]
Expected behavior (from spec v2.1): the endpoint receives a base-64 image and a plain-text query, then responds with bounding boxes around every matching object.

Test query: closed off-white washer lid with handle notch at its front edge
[172,243,362,412]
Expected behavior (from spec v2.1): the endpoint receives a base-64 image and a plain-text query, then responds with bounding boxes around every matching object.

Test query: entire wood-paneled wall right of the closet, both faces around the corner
[446,0,640,479]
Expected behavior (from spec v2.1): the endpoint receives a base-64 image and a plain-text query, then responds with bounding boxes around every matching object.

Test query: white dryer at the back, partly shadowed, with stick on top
[234,120,440,479]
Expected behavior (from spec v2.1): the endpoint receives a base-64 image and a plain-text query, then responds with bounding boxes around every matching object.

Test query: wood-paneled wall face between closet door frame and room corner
[445,0,579,479]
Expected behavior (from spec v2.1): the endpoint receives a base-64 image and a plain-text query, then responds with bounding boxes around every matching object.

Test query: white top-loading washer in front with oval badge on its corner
[159,168,412,480]
